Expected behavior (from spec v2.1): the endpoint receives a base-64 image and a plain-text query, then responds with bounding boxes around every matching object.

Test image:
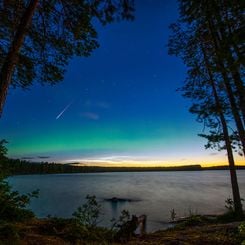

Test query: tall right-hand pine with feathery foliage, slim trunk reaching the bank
[169,0,245,218]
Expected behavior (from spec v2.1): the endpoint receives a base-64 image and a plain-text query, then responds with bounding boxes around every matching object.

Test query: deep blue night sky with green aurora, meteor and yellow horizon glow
[0,0,244,166]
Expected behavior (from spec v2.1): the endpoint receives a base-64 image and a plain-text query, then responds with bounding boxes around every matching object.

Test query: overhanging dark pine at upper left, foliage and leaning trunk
[0,0,134,113]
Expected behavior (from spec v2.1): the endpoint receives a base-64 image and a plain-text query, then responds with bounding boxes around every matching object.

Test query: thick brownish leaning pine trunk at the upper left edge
[0,0,38,116]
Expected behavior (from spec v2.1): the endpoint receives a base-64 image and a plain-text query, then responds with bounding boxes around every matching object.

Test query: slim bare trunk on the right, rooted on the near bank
[202,47,243,220]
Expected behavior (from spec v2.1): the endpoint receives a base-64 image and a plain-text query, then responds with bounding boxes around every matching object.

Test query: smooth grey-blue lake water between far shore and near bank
[8,170,245,231]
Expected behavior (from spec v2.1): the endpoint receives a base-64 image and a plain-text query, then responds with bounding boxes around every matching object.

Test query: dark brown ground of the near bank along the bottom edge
[0,215,245,245]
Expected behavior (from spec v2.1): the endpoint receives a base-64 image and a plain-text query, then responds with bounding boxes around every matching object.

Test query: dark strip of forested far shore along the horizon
[0,159,245,176]
